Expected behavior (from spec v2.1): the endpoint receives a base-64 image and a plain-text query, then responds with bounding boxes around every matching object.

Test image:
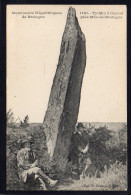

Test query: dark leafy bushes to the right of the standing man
[87,125,127,177]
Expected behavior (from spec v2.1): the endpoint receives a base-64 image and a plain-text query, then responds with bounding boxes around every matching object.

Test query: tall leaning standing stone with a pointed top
[43,7,86,169]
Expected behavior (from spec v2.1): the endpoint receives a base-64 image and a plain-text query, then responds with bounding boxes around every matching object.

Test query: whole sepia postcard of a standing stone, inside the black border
[6,4,128,191]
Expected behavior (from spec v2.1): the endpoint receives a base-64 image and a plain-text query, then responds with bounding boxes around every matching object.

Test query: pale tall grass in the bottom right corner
[59,161,127,191]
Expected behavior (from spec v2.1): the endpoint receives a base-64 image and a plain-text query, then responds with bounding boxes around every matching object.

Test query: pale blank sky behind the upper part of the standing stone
[6,5,127,123]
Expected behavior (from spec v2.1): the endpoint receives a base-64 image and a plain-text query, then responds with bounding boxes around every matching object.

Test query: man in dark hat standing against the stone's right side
[69,123,91,179]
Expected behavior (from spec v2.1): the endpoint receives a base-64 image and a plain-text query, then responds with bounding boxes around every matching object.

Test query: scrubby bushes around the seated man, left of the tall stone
[6,126,49,190]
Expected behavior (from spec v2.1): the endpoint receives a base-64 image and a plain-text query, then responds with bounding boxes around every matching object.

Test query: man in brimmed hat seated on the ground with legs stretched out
[17,139,57,190]
